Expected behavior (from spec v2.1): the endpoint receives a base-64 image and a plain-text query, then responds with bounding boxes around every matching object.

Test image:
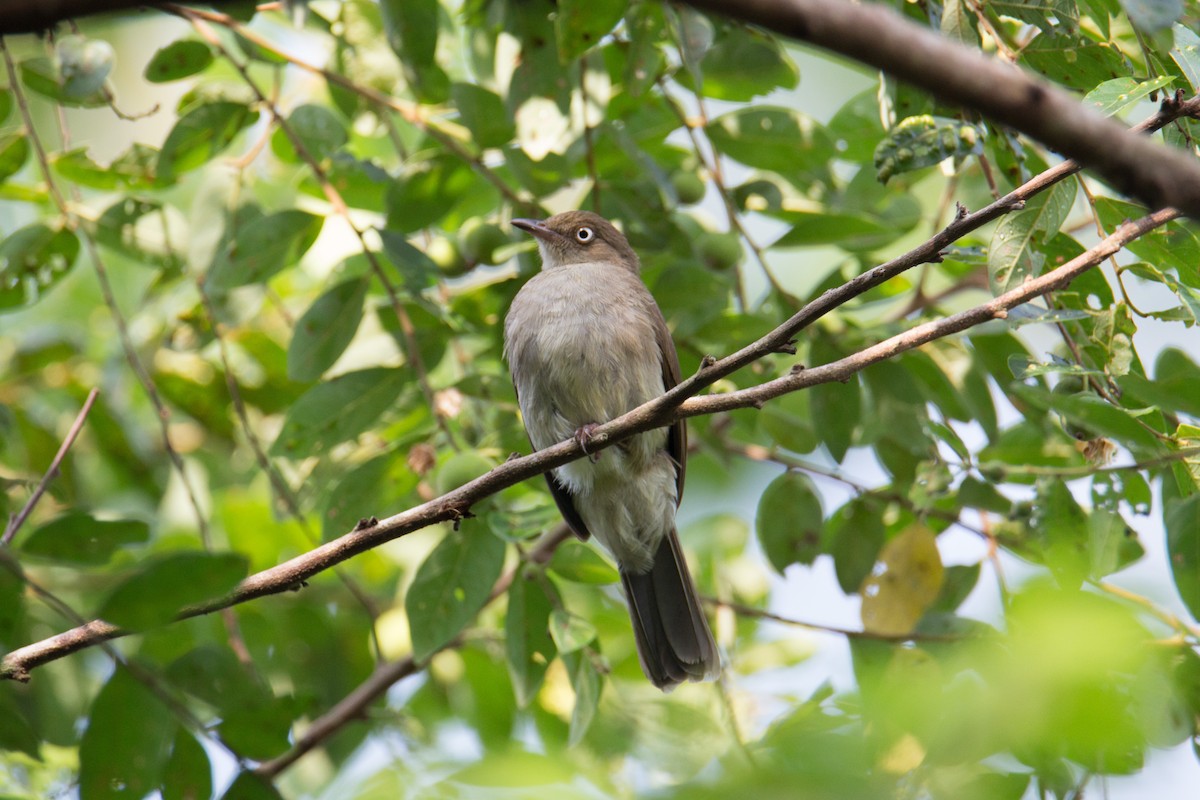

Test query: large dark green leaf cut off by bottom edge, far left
[79,666,179,799]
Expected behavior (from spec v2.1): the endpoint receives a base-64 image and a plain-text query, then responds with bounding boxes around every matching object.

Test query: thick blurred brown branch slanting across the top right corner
[684,0,1200,218]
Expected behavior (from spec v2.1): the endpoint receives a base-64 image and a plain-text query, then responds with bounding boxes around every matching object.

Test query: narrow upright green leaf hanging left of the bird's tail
[497,568,556,708]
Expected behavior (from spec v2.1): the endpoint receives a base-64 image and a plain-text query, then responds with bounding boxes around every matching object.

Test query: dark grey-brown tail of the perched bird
[620,528,721,691]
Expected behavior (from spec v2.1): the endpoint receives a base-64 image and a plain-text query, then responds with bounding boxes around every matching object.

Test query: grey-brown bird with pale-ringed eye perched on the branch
[504,211,720,690]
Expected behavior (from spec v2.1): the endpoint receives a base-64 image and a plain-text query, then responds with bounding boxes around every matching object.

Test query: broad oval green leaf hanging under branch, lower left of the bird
[404,529,505,662]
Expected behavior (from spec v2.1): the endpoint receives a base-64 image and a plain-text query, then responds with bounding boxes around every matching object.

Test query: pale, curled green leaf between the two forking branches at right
[988,181,1075,295]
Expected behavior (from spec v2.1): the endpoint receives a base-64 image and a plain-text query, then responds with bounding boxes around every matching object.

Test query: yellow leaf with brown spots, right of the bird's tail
[860,525,944,636]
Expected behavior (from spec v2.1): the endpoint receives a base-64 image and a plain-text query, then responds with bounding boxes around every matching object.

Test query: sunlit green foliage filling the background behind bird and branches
[0,0,1200,800]
